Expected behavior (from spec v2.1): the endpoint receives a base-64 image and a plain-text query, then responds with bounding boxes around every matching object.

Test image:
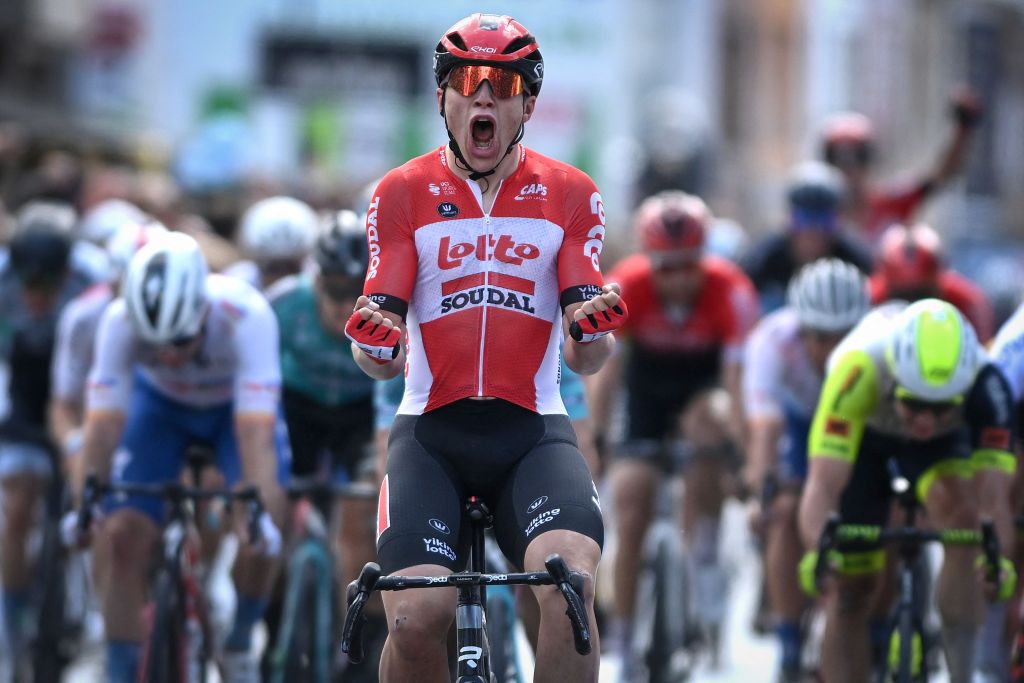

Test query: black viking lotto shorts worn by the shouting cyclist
[377,398,604,573]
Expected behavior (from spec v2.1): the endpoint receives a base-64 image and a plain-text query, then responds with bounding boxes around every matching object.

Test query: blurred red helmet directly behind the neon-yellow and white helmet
[879,223,943,294]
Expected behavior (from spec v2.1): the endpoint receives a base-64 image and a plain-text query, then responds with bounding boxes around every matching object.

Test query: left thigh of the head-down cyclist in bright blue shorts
[116,379,191,524]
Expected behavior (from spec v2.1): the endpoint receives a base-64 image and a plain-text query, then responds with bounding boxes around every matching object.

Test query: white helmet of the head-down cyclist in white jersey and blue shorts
[121,232,209,345]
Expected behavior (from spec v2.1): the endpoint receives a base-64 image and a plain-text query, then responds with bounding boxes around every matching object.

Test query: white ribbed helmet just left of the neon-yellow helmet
[786,258,870,332]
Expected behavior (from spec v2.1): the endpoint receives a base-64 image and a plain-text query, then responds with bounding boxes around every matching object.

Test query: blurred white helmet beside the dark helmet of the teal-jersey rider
[239,197,319,261]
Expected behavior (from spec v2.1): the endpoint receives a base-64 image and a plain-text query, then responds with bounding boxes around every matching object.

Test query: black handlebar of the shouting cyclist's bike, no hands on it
[341,554,593,664]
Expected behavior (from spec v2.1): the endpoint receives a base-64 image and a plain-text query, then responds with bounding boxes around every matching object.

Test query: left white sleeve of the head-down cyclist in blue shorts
[85,299,135,413]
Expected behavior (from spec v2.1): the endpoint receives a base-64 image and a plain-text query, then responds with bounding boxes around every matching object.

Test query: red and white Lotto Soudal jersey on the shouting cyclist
[364,145,604,415]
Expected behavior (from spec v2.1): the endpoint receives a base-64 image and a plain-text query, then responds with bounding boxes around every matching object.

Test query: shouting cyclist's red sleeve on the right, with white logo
[558,172,602,309]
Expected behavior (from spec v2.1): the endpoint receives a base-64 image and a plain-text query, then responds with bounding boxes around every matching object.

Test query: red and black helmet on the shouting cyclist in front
[434,12,544,95]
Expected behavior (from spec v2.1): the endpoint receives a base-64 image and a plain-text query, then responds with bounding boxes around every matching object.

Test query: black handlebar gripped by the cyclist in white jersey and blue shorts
[78,474,264,545]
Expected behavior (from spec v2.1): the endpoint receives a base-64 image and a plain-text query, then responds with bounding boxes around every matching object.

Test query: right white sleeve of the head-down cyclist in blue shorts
[234,295,281,416]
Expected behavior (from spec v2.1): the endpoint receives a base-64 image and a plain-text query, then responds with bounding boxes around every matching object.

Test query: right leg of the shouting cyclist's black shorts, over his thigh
[495,415,604,569]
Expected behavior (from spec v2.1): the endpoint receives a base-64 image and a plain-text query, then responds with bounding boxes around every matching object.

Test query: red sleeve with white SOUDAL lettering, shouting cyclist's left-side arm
[362,169,419,318]
